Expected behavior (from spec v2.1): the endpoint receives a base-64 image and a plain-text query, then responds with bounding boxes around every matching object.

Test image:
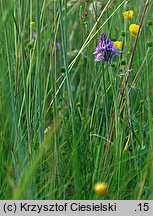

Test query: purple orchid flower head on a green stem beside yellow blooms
[94,33,120,63]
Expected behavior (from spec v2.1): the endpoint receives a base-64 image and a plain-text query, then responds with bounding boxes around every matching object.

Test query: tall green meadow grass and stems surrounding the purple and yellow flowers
[0,0,153,200]
